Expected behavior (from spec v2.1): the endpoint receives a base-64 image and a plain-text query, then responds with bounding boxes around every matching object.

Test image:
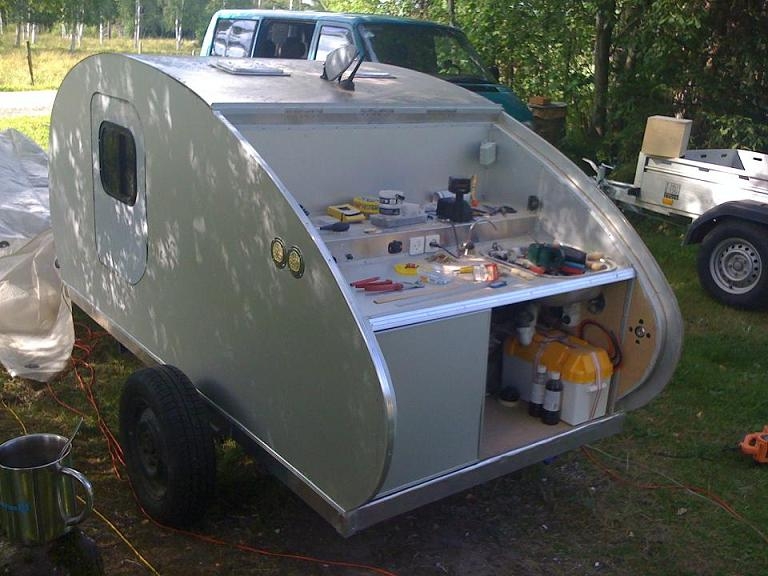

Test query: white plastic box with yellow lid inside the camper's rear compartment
[502,332,613,425]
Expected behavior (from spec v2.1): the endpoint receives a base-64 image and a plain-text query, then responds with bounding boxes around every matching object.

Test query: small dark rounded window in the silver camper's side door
[99,122,137,206]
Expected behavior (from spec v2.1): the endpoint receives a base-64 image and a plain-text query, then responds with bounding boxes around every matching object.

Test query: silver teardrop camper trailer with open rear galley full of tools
[50,54,682,535]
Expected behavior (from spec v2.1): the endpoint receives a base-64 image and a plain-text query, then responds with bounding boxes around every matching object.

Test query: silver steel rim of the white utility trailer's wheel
[710,238,763,294]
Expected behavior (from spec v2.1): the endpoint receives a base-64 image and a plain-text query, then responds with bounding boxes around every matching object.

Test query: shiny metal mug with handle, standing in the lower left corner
[0,434,93,545]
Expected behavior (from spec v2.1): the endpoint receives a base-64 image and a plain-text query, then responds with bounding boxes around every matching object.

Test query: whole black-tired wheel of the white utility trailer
[696,222,768,309]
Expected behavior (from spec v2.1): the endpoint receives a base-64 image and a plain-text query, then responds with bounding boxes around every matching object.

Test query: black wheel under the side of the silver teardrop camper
[120,366,216,527]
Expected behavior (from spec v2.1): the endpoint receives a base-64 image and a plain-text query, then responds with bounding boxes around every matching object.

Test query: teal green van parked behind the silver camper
[200,10,533,125]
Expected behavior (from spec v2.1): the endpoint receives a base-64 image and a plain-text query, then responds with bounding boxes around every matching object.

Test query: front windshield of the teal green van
[359,23,494,83]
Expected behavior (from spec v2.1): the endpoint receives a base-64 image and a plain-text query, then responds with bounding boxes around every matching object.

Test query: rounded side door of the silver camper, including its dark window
[91,93,147,284]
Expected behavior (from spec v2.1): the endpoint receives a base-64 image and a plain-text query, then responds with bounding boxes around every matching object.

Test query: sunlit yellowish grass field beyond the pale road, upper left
[0,29,199,92]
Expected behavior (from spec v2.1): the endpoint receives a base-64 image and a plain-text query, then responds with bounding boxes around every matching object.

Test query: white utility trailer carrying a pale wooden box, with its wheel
[598,116,768,308]
